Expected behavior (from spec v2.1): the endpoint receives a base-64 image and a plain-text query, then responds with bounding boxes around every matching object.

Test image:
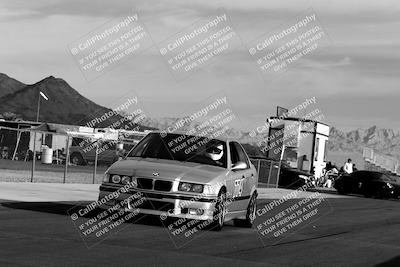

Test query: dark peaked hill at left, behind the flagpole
[0,74,149,129]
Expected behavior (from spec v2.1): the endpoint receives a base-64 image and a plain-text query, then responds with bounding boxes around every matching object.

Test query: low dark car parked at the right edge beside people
[334,171,400,198]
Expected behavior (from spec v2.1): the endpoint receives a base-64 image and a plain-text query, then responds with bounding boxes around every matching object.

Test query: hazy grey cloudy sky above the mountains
[0,0,400,130]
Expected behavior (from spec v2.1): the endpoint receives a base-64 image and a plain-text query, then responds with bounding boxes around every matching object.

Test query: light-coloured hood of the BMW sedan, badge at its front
[108,158,228,184]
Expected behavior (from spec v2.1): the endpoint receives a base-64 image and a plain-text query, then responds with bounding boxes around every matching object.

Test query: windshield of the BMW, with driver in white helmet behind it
[127,133,227,168]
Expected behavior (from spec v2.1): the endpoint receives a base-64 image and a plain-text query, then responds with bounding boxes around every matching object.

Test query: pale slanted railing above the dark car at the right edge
[363,147,400,175]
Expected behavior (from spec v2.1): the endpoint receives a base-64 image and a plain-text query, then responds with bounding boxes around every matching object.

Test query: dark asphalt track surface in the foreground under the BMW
[0,197,400,266]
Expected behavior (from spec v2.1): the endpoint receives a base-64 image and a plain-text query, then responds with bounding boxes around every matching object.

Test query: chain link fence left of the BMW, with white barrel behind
[0,127,142,184]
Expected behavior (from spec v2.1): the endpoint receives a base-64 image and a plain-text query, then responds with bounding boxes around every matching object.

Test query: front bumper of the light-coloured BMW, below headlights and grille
[99,184,217,220]
